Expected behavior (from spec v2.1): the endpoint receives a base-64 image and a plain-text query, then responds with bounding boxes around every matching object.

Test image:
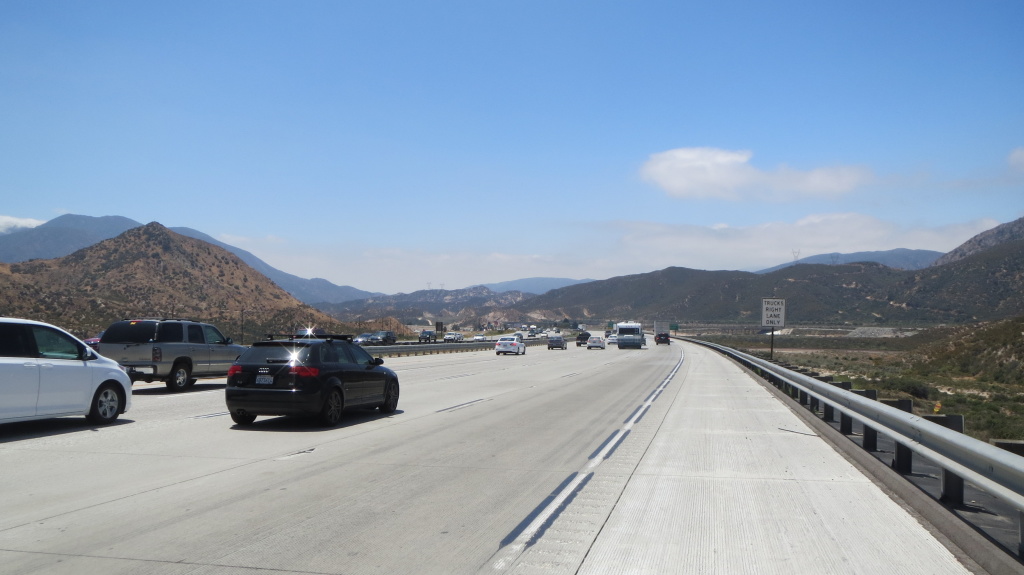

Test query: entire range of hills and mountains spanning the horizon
[0,216,1024,330]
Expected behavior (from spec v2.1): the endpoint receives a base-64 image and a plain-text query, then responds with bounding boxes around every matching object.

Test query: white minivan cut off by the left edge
[0,317,131,425]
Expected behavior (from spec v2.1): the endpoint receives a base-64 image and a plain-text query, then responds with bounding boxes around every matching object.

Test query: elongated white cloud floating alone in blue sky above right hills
[640,147,873,200]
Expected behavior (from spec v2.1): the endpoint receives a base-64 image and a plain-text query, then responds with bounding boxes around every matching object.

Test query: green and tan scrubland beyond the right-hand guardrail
[705,317,1024,441]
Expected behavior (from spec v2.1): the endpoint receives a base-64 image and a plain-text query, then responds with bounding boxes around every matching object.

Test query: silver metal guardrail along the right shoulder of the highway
[684,338,1024,523]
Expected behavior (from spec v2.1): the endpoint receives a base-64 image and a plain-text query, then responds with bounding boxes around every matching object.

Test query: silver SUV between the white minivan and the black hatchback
[97,319,246,391]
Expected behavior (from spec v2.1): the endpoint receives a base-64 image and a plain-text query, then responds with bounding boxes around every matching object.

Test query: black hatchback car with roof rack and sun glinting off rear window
[224,335,398,427]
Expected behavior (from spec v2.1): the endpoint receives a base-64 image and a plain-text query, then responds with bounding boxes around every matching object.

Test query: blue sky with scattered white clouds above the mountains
[0,0,1024,293]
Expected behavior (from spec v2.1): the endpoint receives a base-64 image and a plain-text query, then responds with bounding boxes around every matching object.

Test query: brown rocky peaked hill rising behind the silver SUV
[0,222,351,341]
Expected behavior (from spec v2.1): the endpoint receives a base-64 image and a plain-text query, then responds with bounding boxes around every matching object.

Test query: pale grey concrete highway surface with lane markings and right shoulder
[0,340,991,575]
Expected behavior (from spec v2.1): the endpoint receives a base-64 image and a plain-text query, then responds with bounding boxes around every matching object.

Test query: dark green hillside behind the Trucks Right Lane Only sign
[515,240,1024,325]
